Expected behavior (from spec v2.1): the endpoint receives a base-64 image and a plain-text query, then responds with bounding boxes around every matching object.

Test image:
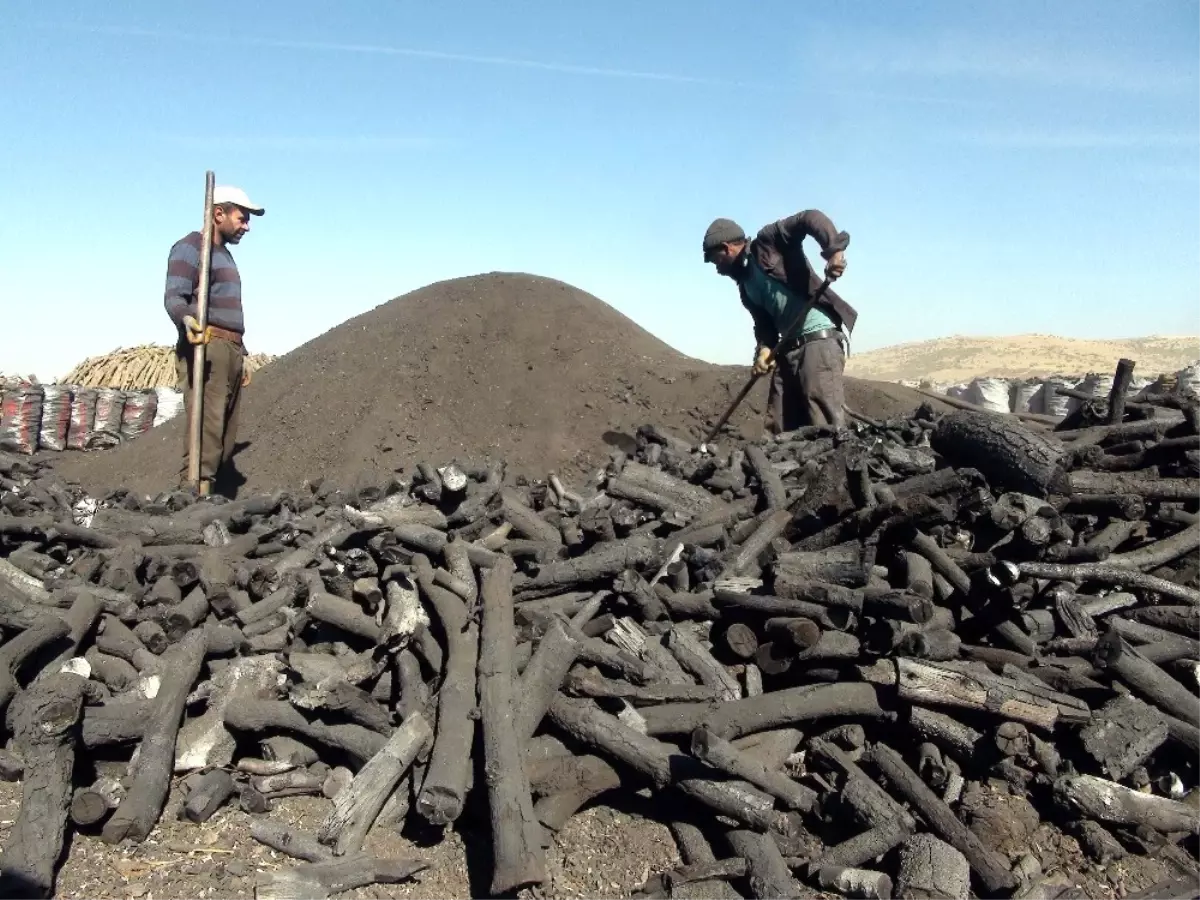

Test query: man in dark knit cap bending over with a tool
[704,209,858,432]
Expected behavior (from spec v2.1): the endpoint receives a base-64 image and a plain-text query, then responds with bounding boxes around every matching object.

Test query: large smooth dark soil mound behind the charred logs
[56,274,940,493]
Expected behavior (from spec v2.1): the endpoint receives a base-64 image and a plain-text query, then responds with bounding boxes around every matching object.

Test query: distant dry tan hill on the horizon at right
[846,335,1200,383]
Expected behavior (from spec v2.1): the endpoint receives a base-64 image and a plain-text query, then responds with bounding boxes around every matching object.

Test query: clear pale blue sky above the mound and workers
[0,0,1200,379]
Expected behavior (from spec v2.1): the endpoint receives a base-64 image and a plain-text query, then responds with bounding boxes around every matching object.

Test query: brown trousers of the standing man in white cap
[175,337,244,484]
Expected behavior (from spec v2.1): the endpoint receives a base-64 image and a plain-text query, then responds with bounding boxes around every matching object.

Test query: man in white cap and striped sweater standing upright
[164,187,265,496]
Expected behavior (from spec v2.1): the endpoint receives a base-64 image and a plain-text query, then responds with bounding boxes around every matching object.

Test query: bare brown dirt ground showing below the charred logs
[0,784,1174,900]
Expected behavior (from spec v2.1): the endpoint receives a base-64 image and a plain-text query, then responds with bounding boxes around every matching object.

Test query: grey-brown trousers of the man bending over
[767,337,846,433]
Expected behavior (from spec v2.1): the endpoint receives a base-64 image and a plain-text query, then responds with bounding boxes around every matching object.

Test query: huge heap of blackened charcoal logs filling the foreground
[0,360,1200,900]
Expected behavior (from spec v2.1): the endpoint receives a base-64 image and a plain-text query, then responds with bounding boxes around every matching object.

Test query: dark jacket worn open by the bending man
[738,209,858,347]
